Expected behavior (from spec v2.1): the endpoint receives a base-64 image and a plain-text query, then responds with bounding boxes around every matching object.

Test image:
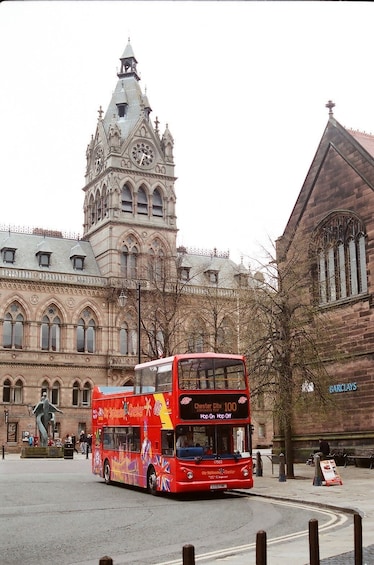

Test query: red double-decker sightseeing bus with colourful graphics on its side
[92,353,253,494]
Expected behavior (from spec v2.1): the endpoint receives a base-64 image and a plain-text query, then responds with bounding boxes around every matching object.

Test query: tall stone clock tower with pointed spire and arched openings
[83,41,177,283]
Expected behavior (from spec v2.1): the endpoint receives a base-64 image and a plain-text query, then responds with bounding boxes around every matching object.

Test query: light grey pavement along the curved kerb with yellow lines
[1,451,374,565]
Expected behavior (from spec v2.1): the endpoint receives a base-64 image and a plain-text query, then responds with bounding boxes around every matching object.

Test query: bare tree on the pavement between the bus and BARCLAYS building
[246,245,330,478]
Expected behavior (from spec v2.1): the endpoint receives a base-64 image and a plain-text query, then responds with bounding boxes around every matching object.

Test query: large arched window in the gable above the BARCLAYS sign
[313,212,367,304]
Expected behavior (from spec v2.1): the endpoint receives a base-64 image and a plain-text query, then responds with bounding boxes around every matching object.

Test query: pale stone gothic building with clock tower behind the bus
[0,43,272,450]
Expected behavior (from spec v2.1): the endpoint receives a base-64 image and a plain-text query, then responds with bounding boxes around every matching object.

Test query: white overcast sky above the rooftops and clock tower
[0,0,374,264]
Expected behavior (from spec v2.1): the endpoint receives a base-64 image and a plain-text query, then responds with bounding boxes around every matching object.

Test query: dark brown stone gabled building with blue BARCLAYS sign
[277,102,374,456]
